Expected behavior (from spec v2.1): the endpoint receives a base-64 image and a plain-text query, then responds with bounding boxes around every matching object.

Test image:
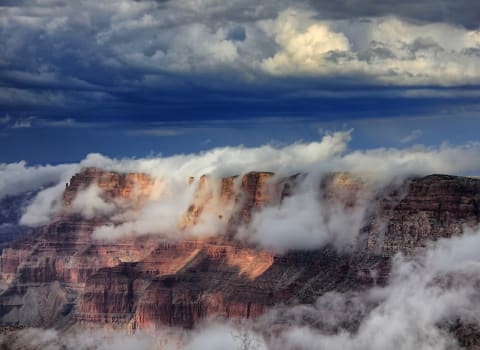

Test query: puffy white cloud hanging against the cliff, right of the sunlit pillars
[239,174,371,252]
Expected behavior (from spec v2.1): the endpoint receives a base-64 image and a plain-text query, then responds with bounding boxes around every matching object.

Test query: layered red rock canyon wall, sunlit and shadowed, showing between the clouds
[0,168,480,329]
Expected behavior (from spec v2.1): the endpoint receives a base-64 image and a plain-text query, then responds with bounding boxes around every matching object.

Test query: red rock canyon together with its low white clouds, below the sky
[0,131,480,349]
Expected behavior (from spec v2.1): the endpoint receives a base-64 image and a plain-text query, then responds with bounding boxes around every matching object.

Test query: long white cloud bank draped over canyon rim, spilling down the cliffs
[0,130,480,252]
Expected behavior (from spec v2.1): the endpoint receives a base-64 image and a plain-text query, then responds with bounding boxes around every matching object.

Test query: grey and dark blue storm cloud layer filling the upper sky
[0,0,480,126]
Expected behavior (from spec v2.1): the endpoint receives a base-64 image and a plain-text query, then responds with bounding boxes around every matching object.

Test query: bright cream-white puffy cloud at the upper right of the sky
[261,9,480,85]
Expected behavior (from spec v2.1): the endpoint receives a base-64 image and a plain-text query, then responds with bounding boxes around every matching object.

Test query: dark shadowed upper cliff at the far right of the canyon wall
[368,175,480,257]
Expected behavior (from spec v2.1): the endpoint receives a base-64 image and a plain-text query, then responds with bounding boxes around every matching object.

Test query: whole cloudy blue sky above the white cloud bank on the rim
[0,0,480,164]
